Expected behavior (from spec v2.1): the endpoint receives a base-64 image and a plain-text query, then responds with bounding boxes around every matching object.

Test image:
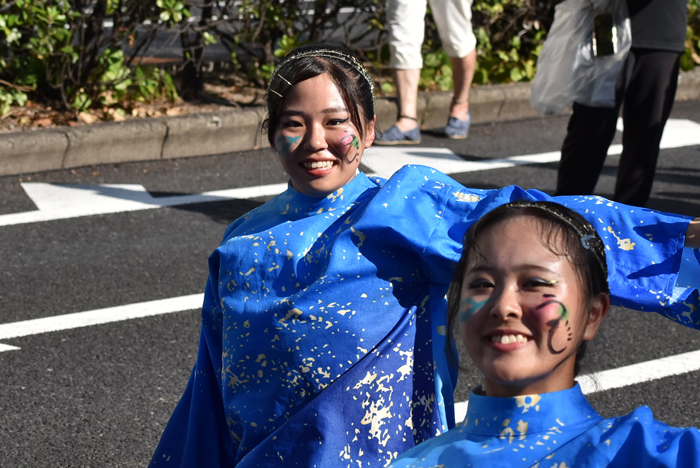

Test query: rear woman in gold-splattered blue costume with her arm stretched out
[151,42,700,468]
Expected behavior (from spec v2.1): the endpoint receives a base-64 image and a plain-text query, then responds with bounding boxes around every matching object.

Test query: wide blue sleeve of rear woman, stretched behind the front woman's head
[368,166,700,328]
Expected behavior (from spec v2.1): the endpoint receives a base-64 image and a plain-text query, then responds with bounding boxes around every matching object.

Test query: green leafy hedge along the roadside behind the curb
[0,0,700,115]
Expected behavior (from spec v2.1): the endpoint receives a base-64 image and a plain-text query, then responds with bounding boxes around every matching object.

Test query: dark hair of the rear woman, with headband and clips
[263,44,374,148]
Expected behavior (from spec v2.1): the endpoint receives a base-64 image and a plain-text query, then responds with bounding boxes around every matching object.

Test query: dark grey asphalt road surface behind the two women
[0,102,700,468]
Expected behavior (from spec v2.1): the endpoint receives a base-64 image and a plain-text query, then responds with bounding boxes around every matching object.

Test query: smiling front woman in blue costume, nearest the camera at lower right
[390,201,700,468]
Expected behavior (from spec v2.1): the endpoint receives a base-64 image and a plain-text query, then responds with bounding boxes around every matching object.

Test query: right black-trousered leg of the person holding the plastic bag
[613,49,681,206]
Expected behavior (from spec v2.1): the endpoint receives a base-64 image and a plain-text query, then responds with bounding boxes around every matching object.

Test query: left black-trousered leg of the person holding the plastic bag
[555,54,634,195]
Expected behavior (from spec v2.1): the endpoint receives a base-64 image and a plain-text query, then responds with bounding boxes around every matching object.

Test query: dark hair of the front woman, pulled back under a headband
[446,201,610,375]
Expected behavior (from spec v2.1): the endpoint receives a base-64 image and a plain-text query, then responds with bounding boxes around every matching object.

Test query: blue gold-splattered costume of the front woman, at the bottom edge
[390,384,700,468]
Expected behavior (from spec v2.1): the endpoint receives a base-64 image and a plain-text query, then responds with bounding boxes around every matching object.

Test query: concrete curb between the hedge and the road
[0,68,700,176]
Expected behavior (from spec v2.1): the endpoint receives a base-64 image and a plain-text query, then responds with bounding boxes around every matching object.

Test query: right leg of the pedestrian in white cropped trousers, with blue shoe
[430,0,476,138]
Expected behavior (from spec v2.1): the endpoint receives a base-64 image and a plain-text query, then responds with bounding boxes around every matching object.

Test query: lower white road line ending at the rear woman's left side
[0,294,204,352]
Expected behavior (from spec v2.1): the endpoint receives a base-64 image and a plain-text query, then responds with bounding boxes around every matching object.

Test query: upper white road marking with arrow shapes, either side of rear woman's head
[0,119,700,226]
